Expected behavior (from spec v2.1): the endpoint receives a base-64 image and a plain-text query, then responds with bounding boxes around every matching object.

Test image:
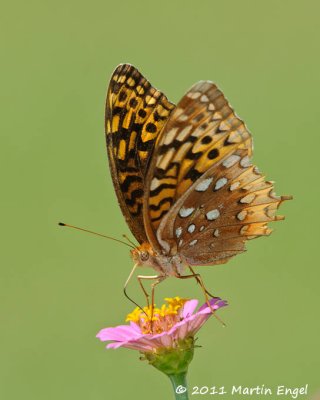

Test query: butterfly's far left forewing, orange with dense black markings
[106,64,174,243]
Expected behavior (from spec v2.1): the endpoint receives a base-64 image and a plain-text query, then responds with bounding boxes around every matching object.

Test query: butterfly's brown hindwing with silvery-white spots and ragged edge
[171,151,285,265]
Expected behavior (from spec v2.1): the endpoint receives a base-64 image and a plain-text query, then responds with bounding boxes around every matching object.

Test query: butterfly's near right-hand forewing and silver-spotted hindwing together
[145,82,285,265]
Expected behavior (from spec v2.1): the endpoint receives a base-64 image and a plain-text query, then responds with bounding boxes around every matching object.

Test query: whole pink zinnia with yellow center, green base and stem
[97,297,227,400]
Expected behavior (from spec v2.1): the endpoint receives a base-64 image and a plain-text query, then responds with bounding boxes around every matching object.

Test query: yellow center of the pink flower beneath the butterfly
[126,297,188,334]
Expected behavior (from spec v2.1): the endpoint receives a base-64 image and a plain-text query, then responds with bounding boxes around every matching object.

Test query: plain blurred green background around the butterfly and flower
[0,0,320,400]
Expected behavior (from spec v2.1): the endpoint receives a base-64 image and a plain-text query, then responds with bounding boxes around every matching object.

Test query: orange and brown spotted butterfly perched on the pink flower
[105,64,292,302]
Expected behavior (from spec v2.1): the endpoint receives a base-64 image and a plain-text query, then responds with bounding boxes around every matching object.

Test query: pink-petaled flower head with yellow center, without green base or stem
[97,297,227,354]
